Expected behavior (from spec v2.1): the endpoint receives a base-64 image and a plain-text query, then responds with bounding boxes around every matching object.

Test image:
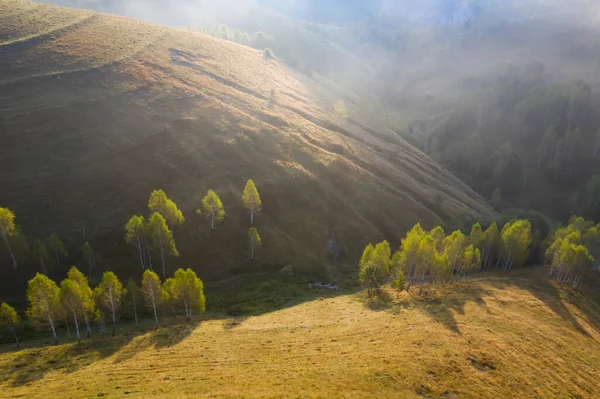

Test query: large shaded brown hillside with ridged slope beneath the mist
[0,0,493,292]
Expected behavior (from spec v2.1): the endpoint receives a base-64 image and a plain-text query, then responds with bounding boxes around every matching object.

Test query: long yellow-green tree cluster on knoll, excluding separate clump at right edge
[359,219,532,296]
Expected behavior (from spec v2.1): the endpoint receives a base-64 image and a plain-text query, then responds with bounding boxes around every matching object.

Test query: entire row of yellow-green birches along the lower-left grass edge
[0,266,206,347]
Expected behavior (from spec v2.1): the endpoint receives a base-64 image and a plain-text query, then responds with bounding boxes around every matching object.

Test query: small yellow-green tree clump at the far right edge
[546,217,600,289]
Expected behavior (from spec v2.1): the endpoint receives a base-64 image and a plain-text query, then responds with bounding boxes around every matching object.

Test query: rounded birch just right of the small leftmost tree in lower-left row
[25,273,61,345]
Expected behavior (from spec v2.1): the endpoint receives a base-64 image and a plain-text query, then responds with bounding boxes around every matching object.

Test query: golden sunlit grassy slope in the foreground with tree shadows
[0,268,600,399]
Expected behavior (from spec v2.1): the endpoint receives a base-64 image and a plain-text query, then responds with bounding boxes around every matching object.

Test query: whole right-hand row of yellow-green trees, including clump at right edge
[359,216,600,296]
